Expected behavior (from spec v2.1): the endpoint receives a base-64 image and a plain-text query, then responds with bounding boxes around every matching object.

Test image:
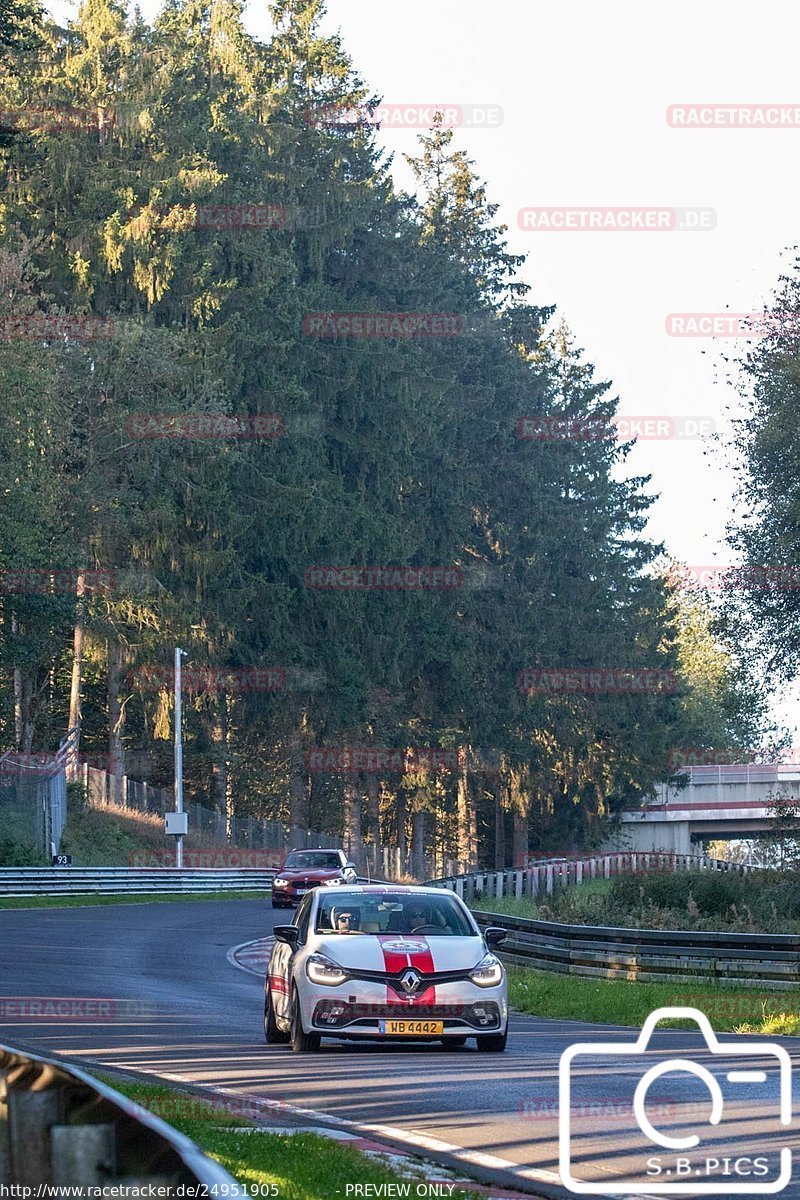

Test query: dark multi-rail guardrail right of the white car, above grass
[473,910,800,988]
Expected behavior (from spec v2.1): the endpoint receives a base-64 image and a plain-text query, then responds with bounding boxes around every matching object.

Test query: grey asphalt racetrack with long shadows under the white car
[0,900,800,1200]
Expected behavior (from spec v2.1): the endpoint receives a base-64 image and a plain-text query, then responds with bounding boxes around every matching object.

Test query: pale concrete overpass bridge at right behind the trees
[604,763,800,854]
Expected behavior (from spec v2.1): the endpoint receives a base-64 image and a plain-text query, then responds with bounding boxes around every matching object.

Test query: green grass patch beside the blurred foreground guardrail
[107,1078,482,1200]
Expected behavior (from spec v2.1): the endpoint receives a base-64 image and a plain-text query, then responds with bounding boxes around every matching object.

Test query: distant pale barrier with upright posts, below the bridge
[428,851,753,900]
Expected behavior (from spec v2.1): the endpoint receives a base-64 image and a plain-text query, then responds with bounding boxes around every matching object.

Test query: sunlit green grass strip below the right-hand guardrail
[507,966,800,1034]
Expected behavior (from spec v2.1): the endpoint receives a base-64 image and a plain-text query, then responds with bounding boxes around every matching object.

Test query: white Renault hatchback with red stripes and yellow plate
[264,884,509,1051]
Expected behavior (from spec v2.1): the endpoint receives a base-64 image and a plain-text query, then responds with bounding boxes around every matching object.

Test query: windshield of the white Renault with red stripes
[317,889,477,937]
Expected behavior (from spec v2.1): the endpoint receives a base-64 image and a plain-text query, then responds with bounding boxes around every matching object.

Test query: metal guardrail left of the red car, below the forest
[0,866,277,896]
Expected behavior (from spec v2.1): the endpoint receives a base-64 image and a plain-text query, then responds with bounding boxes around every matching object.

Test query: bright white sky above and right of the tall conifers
[45,0,800,744]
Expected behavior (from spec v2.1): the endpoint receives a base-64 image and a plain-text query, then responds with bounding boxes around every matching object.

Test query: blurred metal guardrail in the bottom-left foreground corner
[0,1044,247,1200]
